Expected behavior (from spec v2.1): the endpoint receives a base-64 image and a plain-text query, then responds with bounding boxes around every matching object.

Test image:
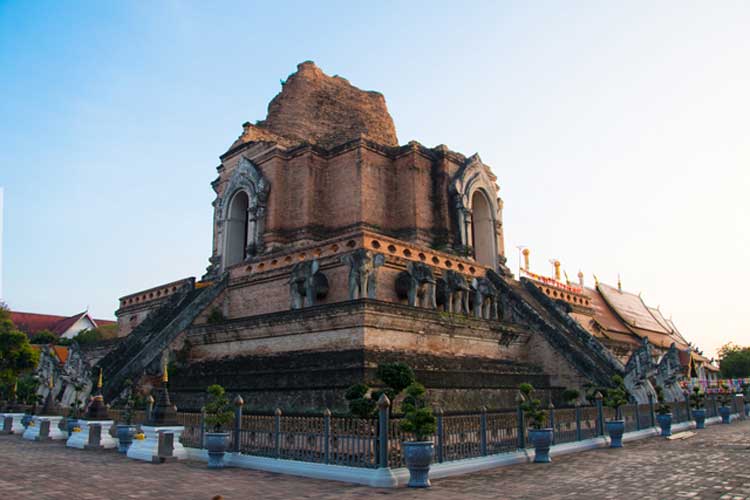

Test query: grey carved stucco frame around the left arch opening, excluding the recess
[207,156,271,275]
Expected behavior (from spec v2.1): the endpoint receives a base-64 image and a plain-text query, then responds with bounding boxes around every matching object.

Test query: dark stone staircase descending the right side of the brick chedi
[487,271,625,386]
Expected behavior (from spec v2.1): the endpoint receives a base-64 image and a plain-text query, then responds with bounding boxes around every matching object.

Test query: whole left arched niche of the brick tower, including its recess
[211,156,270,270]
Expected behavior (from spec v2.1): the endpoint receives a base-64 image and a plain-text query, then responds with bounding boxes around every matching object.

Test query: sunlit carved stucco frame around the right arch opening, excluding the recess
[449,154,502,267]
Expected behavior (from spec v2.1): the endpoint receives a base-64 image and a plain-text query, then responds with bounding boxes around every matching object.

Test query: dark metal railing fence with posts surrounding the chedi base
[100,397,744,468]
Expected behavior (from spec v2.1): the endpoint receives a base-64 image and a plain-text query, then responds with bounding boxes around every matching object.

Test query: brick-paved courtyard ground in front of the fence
[0,420,750,500]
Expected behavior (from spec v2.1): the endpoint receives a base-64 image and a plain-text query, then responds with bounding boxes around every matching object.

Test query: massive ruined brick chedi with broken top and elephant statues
[100,62,700,411]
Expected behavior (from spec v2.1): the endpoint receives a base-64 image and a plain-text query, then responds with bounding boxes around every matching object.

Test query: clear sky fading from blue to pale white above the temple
[0,0,750,354]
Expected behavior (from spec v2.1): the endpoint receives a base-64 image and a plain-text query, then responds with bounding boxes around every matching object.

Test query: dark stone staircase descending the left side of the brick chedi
[100,274,228,402]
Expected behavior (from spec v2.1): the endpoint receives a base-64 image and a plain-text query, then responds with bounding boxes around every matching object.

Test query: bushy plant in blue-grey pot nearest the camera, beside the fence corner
[401,382,436,488]
